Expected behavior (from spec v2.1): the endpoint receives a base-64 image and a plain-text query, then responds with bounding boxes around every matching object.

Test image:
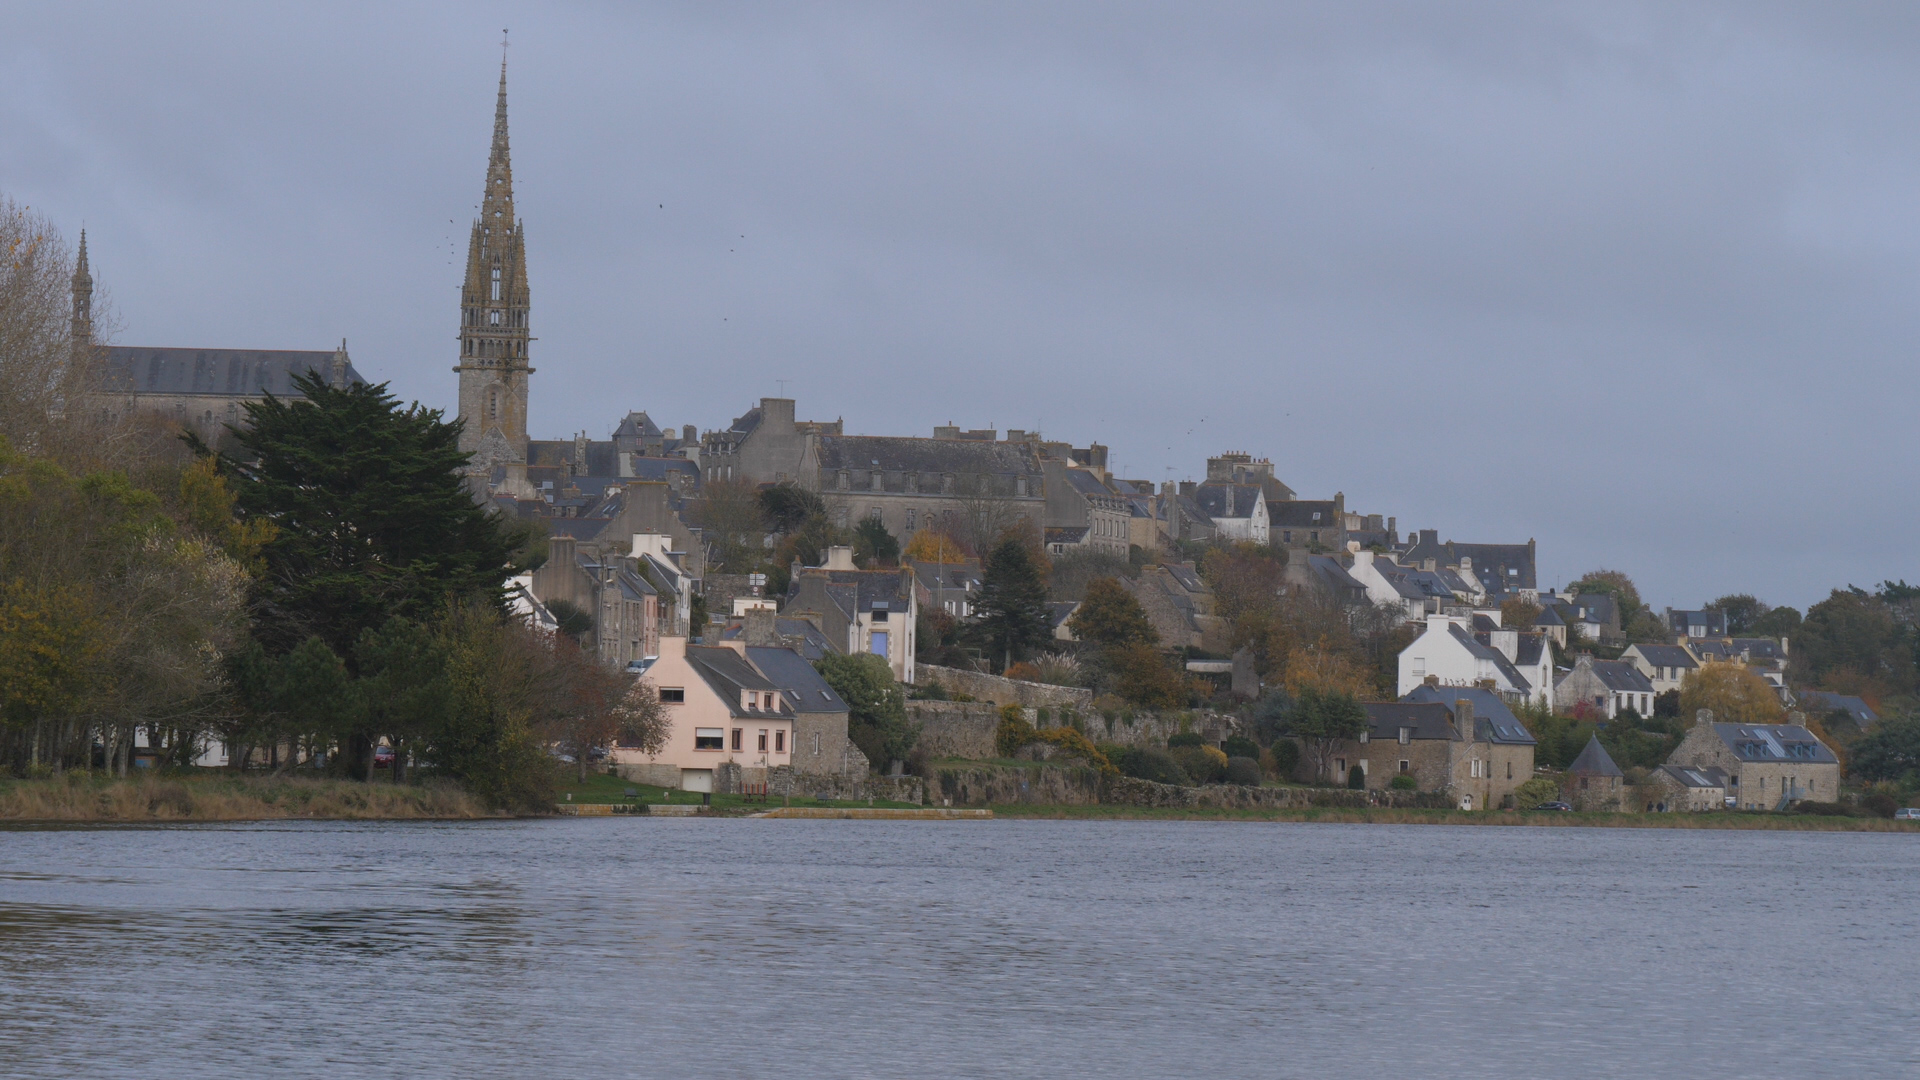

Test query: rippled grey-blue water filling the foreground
[0,819,1920,1078]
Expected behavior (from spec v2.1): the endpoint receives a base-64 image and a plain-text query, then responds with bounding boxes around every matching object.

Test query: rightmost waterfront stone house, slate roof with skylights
[1667,709,1839,809]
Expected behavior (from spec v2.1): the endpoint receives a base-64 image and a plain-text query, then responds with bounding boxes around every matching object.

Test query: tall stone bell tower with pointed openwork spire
[453,48,534,479]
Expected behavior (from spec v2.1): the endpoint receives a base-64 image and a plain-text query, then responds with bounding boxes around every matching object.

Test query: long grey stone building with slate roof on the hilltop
[801,434,1046,542]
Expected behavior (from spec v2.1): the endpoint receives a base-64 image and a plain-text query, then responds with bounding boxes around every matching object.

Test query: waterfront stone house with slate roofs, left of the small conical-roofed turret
[1332,686,1534,809]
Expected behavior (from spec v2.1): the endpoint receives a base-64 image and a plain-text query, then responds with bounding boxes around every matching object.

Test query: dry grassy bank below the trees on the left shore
[0,773,493,822]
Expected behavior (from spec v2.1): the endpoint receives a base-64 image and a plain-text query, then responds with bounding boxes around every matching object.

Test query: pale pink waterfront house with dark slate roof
[611,636,795,792]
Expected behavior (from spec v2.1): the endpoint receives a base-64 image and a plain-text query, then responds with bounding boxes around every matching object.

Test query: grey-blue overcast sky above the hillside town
[0,0,1920,605]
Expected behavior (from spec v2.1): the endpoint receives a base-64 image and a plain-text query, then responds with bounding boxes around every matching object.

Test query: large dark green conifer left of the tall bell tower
[225,368,518,655]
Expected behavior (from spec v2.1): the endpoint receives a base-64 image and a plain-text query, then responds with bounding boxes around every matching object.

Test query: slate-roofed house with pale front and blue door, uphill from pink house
[780,548,920,682]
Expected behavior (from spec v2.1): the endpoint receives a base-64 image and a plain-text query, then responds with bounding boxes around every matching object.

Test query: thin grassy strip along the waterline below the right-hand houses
[993,803,1920,822]
